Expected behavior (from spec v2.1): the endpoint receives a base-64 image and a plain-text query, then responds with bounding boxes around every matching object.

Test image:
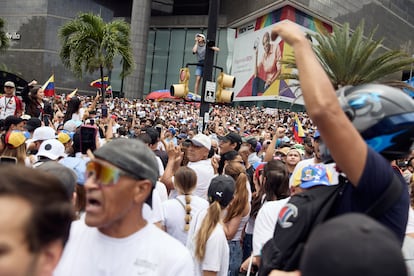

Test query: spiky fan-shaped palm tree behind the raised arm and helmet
[280,21,414,89]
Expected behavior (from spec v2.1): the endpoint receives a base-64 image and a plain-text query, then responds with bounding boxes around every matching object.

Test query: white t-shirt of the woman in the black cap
[187,210,230,276]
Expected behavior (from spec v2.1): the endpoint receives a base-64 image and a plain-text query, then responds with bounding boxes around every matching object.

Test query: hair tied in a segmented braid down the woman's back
[174,166,197,232]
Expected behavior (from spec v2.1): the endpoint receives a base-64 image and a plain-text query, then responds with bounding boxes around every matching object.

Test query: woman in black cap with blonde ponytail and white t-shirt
[187,175,235,276]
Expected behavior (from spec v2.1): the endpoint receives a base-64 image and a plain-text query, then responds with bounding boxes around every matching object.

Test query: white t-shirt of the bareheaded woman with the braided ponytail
[162,195,209,245]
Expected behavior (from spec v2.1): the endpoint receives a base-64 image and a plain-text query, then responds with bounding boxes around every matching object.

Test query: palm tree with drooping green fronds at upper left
[59,13,134,95]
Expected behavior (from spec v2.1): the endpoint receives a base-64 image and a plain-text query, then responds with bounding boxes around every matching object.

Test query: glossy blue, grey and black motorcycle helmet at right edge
[325,84,414,161]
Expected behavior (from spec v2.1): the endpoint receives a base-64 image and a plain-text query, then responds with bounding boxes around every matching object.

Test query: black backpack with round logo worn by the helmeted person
[259,173,403,276]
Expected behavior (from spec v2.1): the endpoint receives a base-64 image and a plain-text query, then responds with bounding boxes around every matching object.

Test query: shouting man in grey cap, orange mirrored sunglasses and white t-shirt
[54,139,194,276]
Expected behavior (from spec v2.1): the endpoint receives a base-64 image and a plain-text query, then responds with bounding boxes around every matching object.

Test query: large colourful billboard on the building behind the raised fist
[232,6,332,104]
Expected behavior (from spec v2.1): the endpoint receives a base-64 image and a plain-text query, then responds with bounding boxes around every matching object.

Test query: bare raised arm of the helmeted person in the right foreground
[272,21,367,186]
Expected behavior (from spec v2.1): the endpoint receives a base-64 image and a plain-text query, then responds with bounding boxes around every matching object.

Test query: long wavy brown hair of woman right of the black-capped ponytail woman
[223,161,249,223]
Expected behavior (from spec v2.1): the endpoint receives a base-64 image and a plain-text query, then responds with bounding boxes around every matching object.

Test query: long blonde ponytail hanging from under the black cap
[195,201,221,262]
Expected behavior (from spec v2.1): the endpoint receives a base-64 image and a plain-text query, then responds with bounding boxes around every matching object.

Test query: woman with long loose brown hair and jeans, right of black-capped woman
[223,161,250,276]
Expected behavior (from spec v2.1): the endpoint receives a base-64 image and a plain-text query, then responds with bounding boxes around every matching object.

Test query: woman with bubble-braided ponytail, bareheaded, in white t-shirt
[162,167,208,245]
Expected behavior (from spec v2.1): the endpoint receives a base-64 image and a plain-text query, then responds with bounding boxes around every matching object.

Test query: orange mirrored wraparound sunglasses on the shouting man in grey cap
[85,160,135,186]
